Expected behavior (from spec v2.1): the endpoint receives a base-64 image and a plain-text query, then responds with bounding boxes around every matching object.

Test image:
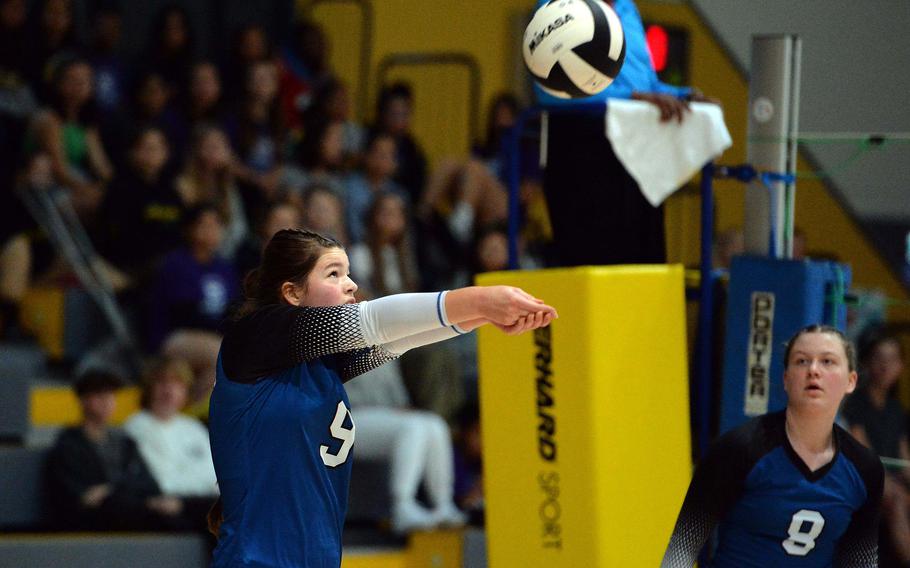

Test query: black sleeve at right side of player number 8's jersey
[834,426,885,568]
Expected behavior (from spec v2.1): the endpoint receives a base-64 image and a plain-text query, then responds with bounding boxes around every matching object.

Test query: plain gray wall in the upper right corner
[689,0,910,221]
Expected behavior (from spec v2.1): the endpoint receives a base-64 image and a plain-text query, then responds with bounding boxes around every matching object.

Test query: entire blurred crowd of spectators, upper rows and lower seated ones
[0,0,549,529]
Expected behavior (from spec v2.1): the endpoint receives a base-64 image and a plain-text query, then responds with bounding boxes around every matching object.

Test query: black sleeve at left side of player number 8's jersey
[661,415,778,568]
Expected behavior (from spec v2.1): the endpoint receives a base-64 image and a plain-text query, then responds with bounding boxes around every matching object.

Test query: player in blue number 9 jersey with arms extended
[209,230,556,568]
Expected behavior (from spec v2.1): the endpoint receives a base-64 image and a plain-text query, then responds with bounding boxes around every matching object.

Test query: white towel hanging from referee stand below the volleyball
[606,99,732,207]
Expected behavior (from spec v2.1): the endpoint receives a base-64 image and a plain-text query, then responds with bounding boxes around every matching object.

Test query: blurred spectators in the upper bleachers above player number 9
[0,0,548,353]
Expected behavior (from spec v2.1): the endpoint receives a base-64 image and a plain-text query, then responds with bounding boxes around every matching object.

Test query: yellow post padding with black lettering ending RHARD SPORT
[478,265,691,568]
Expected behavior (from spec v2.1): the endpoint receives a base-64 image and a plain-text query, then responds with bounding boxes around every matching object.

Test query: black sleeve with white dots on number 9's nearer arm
[221,304,370,383]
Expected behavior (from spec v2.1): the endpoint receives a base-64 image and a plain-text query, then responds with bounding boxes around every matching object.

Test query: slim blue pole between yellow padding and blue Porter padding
[694,162,714,457]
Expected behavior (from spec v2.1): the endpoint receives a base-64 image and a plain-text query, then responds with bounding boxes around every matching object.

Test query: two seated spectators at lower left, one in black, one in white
[45,359,218,533]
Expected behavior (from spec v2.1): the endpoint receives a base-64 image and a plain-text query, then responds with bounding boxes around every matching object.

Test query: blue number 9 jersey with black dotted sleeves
[209,305,393,568]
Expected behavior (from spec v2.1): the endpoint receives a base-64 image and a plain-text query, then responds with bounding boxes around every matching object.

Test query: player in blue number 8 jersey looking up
[662,325,884,568]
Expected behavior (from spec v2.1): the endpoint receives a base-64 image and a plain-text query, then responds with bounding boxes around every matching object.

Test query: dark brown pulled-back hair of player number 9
[235,229,344,318]
